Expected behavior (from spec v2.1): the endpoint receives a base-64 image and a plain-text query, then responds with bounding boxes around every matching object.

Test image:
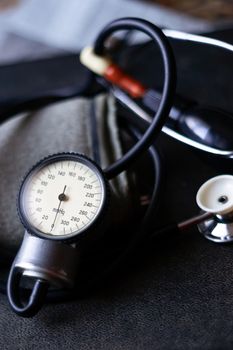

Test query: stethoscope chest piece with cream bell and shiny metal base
[196,175,233,243]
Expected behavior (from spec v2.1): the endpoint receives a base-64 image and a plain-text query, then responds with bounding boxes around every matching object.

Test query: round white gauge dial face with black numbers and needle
[19,154,106,239]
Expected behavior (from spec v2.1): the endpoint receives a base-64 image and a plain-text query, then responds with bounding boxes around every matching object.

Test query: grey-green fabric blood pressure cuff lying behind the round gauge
[0,94,133,252]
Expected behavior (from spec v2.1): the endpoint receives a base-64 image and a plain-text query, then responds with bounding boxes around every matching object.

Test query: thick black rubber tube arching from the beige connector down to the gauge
[94,17,176,179]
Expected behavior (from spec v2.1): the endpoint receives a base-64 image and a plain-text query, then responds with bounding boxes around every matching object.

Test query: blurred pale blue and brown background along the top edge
[0,0,233,64]
